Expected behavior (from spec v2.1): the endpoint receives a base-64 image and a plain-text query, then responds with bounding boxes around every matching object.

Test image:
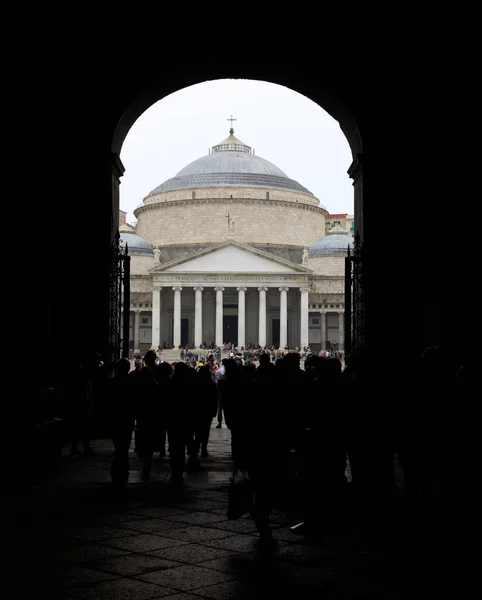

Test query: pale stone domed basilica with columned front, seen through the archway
[120,128,353,352]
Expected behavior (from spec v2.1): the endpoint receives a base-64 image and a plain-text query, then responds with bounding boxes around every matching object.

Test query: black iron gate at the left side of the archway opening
[107,230,131,376]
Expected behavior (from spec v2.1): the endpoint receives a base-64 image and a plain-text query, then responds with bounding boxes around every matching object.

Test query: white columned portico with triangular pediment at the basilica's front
[152,241,311,348]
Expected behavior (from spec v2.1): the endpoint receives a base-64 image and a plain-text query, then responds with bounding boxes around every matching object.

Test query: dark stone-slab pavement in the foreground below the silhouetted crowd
[13,422,412,600]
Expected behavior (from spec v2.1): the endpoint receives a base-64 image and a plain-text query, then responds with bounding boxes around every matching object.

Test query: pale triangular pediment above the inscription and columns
[150,241,312,274]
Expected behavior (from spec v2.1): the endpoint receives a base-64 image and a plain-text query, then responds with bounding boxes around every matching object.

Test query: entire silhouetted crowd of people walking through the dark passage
[54,347,470,546]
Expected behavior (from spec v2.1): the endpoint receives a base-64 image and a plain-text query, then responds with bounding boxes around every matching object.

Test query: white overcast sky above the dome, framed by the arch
[120,79,353,223]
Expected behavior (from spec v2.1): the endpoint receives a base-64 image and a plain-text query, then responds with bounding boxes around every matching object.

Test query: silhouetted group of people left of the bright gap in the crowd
[110,350,218,485]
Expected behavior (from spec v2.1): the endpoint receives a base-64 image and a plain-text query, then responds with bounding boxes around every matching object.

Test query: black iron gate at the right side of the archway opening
[345,233,365,355]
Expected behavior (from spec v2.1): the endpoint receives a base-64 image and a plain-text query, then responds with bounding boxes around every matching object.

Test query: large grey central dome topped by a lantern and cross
[148,129,313,196]
